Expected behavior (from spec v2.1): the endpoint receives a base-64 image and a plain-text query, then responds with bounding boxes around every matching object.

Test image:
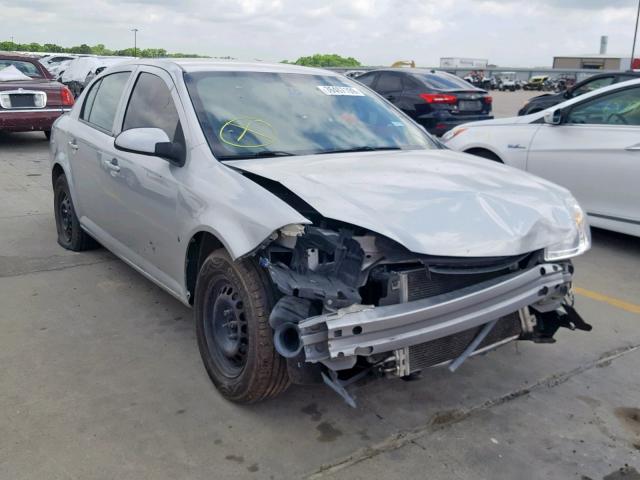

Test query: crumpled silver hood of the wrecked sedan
[224,150,575,257]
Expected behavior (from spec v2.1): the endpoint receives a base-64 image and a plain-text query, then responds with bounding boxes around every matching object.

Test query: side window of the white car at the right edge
[567,87,640,125]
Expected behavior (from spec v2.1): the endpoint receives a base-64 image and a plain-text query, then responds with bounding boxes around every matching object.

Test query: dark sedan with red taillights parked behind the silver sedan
[356,68,493,135]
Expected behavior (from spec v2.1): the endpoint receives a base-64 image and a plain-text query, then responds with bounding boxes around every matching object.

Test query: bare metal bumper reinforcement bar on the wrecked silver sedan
[299,263,572,370]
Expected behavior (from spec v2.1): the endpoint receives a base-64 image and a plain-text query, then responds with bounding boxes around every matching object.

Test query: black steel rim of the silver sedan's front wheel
[204,279,249,378]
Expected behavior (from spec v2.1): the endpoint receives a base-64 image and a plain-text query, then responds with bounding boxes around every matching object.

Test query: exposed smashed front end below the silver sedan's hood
[260,219,591,404]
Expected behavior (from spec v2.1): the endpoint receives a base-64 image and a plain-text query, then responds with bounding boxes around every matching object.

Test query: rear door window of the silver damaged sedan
[81,72,131,132]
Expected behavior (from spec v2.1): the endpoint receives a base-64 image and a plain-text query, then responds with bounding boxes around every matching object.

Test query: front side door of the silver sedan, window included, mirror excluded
[103,67,186,292]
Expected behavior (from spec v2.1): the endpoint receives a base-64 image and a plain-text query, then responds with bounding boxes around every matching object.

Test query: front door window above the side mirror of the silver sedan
[122,72,180,142]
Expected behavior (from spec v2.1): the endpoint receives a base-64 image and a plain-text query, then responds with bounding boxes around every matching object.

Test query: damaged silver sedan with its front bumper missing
[51,60,591,404]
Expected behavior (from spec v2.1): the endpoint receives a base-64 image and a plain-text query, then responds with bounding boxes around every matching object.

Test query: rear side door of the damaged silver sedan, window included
[67,71,131,236]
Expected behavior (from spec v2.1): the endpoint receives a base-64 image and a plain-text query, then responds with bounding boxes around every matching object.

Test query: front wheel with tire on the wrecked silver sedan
[194,249,289,403]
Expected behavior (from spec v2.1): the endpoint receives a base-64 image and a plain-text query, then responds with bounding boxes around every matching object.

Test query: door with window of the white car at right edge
[527,86,640,229]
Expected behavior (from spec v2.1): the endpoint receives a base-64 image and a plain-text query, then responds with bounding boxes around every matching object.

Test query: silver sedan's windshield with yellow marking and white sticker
[185,72,438,160]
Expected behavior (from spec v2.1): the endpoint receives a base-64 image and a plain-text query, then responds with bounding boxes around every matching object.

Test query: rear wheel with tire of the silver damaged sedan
[53,174,98,252]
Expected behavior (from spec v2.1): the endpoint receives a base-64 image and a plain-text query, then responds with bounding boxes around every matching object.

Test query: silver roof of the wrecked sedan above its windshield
[108,58,338,76]
